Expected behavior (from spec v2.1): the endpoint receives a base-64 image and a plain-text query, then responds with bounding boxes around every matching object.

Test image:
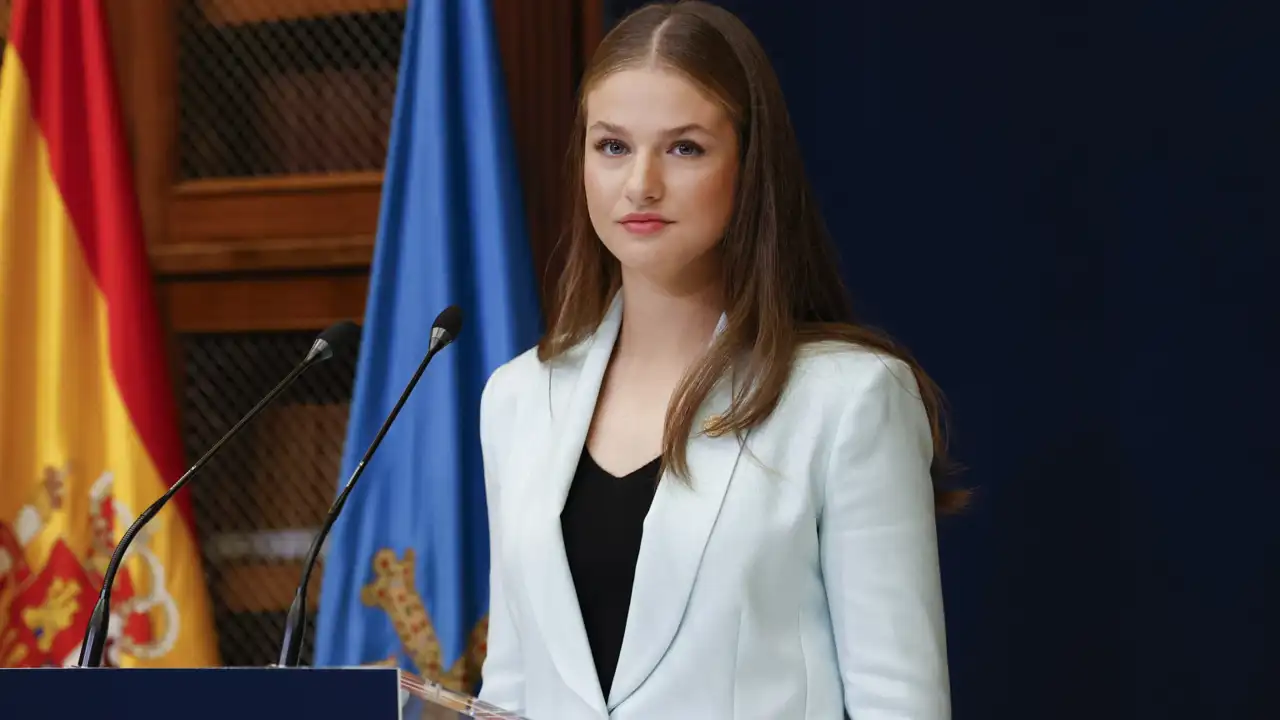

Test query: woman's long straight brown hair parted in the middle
[538,1,966,511]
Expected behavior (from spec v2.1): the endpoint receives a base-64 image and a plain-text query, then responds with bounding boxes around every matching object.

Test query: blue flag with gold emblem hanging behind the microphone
[315,1,541,689]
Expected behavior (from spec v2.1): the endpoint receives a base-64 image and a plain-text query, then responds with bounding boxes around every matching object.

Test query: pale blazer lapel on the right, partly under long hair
[608,310,745,708]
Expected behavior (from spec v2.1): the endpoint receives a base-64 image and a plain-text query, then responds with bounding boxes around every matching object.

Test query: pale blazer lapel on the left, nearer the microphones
[520,293,622,715]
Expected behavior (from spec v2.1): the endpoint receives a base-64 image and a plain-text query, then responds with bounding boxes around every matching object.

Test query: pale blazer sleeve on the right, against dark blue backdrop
[819,359,951,720]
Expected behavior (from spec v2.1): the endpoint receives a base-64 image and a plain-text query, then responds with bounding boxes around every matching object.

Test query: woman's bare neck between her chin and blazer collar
[614,270,723,365]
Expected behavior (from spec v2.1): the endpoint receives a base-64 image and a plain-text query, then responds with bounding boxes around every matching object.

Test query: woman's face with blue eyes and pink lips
[582,69,739,290]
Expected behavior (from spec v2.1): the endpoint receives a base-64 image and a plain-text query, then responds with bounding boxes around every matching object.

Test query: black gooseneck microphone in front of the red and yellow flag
[79,320,360,667]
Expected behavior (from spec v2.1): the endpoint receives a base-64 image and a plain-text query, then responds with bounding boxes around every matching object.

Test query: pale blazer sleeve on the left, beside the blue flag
[480,368,525,714]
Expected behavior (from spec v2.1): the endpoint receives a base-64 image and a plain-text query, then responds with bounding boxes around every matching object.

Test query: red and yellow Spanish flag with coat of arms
[0,0,218,667]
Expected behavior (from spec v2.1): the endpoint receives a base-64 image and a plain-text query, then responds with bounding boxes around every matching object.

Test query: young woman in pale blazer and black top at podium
[481,3,957,720]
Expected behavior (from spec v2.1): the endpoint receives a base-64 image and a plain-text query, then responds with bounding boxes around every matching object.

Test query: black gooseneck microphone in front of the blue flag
[276,305,462,667]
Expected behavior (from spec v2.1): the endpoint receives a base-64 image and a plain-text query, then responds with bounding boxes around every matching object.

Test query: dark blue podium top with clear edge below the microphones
[0,667,525,720]
